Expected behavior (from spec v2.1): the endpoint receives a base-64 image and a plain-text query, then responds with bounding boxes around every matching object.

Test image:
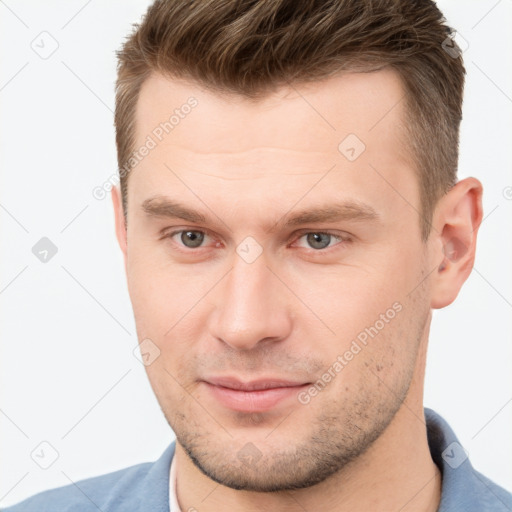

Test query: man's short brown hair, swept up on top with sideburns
[115,0,465,240]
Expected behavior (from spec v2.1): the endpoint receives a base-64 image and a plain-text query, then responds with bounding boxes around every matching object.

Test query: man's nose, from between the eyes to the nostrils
[205,248,292,350]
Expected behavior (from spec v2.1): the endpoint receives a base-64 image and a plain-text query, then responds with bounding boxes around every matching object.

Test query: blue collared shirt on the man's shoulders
[4,408,512,512]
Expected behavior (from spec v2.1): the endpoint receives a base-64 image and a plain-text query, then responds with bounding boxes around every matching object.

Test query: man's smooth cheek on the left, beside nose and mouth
[127,244,216,386]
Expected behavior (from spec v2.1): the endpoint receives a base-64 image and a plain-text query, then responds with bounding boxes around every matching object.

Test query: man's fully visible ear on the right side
[431,178,483,309]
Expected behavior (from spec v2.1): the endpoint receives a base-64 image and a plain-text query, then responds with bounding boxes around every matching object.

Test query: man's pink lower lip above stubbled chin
[204,382,309,412]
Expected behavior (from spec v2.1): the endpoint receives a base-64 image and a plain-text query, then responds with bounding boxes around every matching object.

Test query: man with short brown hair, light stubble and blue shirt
[5,0,512,512]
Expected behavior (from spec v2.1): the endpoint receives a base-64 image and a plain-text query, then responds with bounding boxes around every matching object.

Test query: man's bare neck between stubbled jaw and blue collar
[175,402,441,512]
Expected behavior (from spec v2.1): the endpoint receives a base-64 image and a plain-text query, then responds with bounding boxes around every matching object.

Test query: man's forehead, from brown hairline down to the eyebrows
[128,70,418,238]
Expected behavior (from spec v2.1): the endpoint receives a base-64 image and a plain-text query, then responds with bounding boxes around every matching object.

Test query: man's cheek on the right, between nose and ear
[289,247,428,380]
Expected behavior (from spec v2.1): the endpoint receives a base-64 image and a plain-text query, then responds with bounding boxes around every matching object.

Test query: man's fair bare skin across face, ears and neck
[112,69,482,512]
